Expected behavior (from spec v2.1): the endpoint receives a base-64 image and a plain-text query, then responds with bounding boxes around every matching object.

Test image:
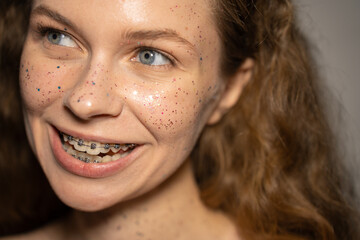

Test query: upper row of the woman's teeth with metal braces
[62,133,135,155]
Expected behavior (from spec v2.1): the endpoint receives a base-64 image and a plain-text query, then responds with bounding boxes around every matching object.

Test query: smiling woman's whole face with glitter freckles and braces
[20,0,224,211]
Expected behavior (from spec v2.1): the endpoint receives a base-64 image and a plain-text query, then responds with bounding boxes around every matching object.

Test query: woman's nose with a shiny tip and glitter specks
[63,63,123,120]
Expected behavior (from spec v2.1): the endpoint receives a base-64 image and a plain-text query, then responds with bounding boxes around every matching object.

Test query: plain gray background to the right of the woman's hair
[294,0,360,207]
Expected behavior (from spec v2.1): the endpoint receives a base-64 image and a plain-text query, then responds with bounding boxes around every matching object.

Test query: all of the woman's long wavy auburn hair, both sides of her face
[0,0,359,240]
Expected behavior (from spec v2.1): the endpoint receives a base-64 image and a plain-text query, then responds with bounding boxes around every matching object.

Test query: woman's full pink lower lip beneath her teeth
[50,128,141,178]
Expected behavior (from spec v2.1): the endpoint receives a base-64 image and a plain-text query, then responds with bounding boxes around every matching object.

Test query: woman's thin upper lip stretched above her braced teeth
[53,126,141,145]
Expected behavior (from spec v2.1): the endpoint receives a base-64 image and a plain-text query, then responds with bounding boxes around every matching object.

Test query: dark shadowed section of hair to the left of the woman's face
[0,0,67,236]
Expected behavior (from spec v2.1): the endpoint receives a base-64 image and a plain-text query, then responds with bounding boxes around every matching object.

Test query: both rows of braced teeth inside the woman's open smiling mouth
[59,132,138,163]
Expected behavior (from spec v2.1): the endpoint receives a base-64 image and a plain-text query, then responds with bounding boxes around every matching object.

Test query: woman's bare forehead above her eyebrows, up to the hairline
[33,0,218,51]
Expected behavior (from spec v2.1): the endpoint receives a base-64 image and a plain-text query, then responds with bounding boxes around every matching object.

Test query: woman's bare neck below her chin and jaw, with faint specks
[54,161,236,239]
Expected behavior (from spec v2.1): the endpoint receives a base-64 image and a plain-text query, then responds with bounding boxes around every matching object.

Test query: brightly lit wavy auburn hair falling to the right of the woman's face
[193,0,359,240]
